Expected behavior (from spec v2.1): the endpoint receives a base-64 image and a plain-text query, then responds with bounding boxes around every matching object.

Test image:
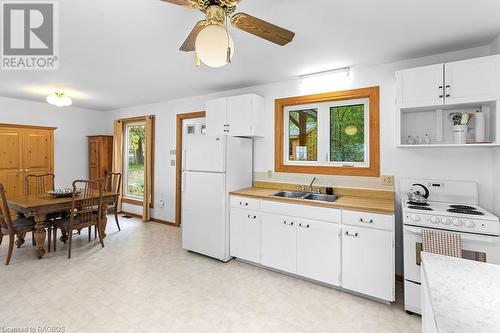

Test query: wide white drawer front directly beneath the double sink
[261,200,340,223]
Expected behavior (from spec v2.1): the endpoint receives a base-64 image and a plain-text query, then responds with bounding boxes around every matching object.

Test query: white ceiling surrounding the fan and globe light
[0,0,500,110]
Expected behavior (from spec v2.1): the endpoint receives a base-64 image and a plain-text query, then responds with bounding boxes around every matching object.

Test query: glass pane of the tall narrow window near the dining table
[124,123,146,200]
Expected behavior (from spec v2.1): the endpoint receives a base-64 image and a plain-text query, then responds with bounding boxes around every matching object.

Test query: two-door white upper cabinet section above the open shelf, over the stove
[396,55,500,108]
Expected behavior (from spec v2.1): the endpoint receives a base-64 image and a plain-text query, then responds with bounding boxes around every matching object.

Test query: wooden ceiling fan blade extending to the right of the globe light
[231,13,295,46]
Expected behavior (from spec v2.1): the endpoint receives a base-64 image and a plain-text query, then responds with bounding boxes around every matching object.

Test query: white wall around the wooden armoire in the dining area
[0,97,108,187]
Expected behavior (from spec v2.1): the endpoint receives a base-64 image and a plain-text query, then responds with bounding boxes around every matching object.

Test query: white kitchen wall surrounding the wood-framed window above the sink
[108,46,494,272]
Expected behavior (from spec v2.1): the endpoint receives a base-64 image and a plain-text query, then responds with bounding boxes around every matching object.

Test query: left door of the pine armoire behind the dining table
[0,128,24,198]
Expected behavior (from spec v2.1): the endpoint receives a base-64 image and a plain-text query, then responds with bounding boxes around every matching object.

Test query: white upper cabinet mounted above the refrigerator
[206,94,264,137]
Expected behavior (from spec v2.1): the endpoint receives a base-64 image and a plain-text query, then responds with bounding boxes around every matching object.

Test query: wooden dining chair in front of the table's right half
[53,179,104,259]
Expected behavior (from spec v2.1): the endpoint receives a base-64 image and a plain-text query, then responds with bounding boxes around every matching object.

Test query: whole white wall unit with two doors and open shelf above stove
[395,55,500,148]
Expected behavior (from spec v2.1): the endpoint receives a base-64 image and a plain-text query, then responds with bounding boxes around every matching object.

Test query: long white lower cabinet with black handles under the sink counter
[230,196,395,302]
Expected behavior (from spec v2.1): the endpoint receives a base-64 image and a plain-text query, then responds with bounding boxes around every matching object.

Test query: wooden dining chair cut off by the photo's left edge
[0,184,35,265]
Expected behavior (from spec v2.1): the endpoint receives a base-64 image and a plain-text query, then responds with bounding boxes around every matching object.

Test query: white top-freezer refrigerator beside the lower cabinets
[181,134,253,262]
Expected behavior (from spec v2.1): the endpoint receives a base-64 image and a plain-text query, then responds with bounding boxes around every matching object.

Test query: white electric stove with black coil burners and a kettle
[400,178,500,313]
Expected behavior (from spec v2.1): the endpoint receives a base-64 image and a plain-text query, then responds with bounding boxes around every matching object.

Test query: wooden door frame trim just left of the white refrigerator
[175,111,205,226]
